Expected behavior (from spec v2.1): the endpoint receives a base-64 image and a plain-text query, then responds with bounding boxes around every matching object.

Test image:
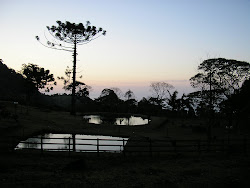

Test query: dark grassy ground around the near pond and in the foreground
[0,103,250,187]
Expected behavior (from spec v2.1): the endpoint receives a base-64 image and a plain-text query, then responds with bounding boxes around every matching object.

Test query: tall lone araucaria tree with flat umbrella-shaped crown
[36,21,106,115]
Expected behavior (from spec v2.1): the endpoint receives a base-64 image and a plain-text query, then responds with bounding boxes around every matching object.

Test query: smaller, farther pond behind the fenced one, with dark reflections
[83,115,150,126]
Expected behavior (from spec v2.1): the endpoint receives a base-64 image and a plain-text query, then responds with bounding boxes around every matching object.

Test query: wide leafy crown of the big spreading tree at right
[190,58,250,95]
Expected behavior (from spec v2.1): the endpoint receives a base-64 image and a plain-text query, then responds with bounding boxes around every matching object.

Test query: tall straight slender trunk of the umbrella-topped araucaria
[71,41,77,115]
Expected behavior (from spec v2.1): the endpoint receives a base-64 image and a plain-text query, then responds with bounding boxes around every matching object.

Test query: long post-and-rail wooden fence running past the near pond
[15,137,249,155]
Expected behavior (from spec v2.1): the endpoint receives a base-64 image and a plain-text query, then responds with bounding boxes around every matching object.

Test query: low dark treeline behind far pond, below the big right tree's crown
[39,80,250,118]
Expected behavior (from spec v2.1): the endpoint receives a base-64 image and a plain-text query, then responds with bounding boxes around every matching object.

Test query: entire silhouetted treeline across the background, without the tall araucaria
[0,58,250,124]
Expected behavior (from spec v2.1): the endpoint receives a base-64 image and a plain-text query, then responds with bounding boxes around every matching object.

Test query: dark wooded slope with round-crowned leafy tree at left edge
[0,59,52,105]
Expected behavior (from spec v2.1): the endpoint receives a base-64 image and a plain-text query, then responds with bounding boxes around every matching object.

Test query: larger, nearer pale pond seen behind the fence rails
[15,133,128,152]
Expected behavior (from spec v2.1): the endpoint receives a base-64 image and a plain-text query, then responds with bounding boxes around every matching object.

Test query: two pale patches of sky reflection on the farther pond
[83,115,150,125]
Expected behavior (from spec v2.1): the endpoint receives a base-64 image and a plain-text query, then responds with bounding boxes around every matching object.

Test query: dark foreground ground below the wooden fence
[0,151,250,187]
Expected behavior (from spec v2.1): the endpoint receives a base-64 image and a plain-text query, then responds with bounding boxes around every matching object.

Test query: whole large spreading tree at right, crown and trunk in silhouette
[190,58,250,140]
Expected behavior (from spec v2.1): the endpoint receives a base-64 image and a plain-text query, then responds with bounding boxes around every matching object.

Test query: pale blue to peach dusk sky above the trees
[0,0,250,99]
